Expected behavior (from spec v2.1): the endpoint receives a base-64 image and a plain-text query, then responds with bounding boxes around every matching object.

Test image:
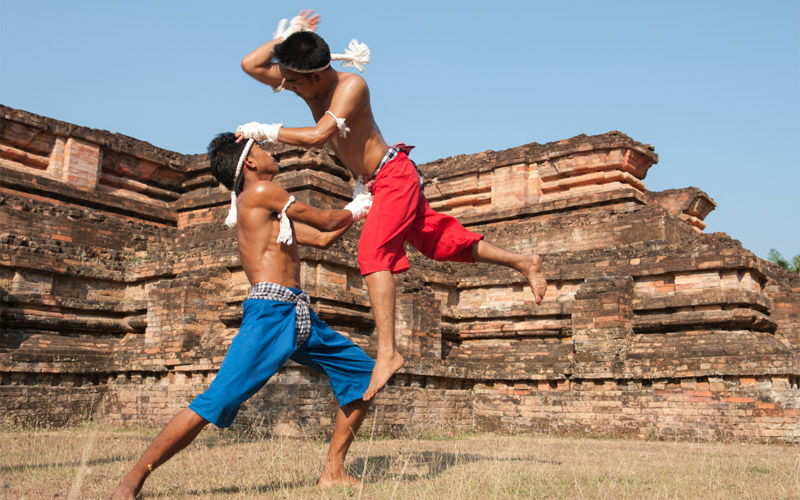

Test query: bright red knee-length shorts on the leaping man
[358,153,483,276]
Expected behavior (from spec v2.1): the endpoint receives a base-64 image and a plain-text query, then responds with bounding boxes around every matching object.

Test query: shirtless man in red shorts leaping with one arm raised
[237,11,547,400]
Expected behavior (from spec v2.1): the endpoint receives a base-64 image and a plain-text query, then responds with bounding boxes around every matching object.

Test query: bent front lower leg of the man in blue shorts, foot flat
[317,399,371,487]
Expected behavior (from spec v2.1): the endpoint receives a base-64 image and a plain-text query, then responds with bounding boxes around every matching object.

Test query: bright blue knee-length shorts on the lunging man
[189,288,375,427]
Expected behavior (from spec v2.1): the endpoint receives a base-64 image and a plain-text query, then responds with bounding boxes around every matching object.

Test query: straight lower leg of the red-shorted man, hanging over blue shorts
[364,271,405,400]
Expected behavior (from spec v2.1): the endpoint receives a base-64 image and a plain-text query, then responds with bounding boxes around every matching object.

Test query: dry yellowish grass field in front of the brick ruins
[0,424,800,500]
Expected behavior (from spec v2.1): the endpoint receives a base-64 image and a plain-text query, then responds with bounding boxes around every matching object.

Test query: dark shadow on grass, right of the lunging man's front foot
[347,451,561,483]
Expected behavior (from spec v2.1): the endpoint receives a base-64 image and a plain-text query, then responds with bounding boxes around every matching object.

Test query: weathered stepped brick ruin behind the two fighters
[0,106,800,442]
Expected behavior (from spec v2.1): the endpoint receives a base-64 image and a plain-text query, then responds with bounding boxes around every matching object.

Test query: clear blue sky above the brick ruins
[0,0,800,257]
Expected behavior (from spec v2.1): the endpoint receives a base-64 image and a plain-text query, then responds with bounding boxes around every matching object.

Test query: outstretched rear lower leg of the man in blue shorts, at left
[108,408,208,500]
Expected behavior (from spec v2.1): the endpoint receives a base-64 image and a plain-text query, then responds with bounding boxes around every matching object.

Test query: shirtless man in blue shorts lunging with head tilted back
[109,133,375,499]
